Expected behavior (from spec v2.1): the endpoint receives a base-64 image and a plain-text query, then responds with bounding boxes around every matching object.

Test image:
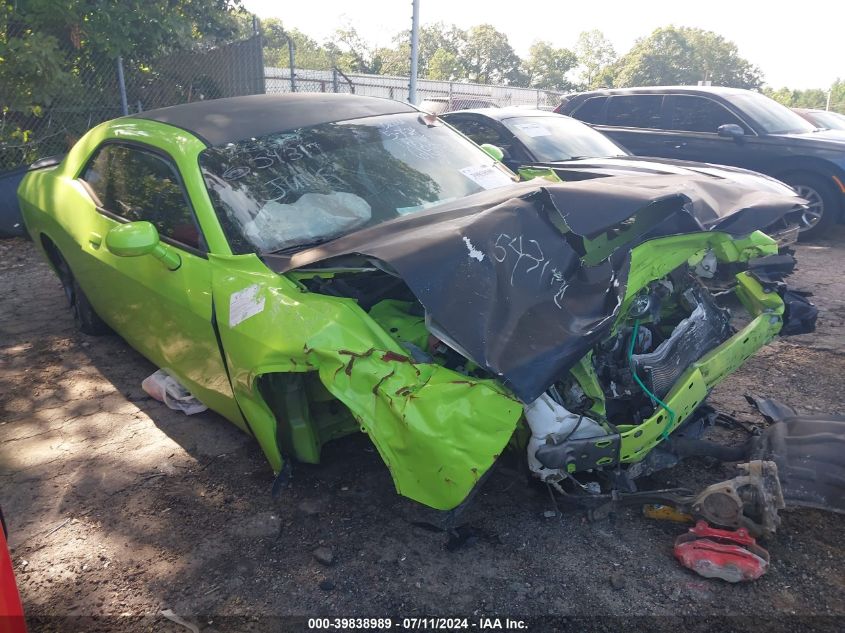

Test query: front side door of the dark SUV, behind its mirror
[661,94,756,167]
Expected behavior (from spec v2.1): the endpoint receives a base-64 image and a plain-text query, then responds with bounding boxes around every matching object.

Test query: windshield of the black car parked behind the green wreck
[502,114,628,162]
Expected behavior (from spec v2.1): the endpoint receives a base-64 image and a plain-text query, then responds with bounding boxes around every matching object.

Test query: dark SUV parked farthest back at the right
[555,86,845,236]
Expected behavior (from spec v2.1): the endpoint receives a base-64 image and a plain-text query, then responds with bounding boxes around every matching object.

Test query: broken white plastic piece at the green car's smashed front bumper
[525,393,607,481]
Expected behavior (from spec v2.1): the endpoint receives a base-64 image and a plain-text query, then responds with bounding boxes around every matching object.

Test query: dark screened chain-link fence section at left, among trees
[0,21,264,173]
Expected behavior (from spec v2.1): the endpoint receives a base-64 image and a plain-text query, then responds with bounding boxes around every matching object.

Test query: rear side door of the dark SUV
[592,94,669,156]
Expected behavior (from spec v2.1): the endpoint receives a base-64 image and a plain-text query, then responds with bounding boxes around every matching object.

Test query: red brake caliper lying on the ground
[675,521,769,582]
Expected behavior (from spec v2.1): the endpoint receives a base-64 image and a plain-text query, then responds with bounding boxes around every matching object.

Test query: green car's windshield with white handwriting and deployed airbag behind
[200,112,516,253]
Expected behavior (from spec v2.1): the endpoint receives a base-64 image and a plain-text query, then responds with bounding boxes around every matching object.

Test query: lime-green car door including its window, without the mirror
[80,141,239,419]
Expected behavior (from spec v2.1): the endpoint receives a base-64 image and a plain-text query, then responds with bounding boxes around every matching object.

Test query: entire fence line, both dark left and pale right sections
[0,13,562,178]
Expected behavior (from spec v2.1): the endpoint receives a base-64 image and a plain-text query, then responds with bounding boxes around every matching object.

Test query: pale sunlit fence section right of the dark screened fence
[264,67,565,114]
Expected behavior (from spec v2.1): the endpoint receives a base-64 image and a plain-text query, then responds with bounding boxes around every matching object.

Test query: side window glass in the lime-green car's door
[82,144,200,248]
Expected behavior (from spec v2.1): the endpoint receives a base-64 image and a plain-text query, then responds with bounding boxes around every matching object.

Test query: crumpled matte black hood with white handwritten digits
[263,176,801,402]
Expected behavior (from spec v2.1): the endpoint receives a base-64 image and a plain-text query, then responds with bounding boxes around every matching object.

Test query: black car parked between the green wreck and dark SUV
[441,106,807,241]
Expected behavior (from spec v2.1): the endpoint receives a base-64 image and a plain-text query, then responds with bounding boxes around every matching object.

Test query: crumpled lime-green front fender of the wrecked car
[210,255,522,510]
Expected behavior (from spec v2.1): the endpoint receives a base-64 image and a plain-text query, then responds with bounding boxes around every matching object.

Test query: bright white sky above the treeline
[242,0,845,89]
